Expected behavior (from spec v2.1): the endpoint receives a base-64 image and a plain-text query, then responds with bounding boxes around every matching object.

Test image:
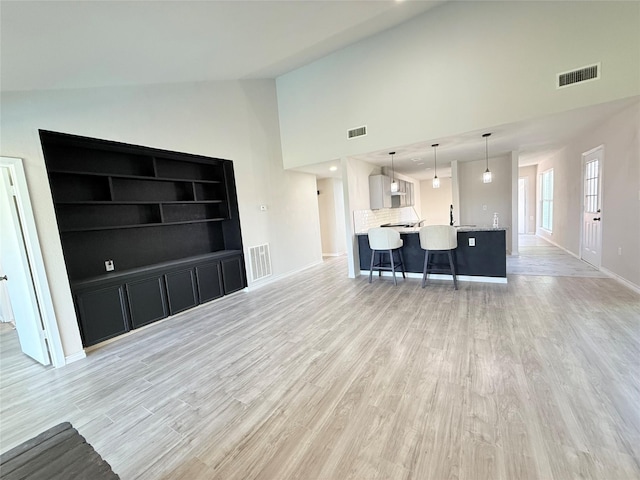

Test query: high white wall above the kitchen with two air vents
[277,1,640,167]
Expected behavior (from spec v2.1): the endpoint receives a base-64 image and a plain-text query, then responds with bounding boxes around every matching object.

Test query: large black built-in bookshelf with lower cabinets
[40,130,246,346]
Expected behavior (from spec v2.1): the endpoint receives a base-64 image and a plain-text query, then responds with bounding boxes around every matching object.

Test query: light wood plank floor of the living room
[0,258,640,480]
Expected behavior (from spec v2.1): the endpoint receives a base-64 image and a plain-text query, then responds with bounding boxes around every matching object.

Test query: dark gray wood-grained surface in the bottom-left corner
[0,422,120,480]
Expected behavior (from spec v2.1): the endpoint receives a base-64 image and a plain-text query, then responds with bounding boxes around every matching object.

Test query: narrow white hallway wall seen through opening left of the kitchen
[318,178,346,255]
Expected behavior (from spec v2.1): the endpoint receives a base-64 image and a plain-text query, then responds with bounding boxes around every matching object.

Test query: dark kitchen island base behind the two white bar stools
[357,228,507,283]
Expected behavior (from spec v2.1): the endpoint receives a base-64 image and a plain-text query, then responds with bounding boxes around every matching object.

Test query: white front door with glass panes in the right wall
[581,147,603,269]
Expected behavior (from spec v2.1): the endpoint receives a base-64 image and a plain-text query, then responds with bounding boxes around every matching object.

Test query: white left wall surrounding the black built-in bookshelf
[0,80,322,356]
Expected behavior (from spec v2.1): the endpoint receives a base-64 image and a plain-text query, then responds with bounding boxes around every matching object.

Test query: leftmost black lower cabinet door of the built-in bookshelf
[75,285,129,347]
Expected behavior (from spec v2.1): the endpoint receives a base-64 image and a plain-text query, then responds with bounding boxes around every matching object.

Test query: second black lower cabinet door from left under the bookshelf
[127,277,169,328]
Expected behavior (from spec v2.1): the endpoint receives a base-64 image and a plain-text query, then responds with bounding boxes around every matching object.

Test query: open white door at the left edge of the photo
[0,168,51,365]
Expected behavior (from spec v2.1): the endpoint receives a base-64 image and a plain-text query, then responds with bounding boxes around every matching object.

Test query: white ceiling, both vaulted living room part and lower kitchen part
[0,0,630,179]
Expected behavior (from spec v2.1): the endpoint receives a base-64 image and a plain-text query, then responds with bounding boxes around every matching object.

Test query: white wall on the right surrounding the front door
[538,102,640,287]
